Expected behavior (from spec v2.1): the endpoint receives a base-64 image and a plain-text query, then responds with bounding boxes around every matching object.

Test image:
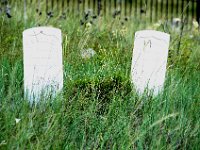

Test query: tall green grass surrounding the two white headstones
[0,3,200,150]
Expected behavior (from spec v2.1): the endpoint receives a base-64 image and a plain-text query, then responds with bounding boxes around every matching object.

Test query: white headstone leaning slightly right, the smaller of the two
[131,30,170,95]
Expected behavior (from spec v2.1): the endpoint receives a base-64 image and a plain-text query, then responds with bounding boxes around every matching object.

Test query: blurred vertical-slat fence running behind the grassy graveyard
[0,0,200,22]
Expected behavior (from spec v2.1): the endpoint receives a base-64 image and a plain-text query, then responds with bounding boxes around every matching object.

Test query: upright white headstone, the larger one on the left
[23,27,63,104]
